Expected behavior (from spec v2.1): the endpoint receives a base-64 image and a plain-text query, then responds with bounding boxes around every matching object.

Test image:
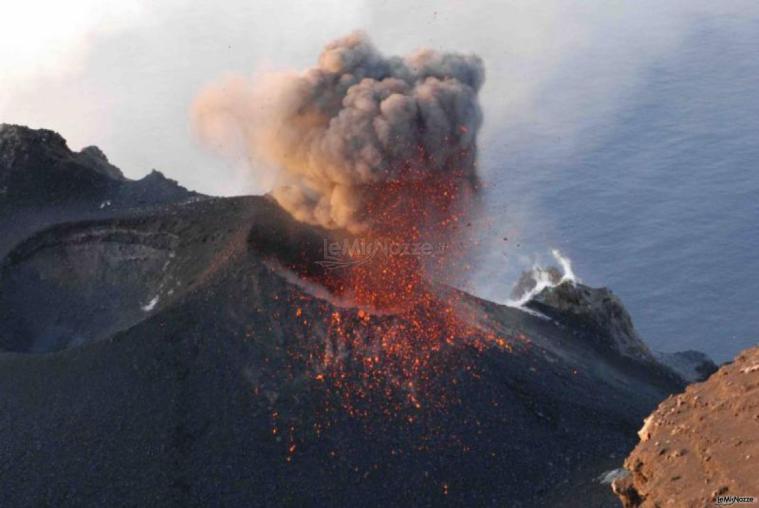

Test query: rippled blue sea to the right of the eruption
[479,20,759,361]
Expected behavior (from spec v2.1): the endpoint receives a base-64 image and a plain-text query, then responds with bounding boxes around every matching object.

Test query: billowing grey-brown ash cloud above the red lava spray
[192,32,484,233]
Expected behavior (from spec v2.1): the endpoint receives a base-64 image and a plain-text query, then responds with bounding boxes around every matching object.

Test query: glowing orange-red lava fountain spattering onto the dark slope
[308,171,507,415]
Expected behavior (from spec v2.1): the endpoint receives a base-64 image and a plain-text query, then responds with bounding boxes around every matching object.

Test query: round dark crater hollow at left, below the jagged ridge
[0,223,178,353]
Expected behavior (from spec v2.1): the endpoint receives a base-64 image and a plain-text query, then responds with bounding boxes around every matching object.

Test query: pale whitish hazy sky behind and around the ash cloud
[0,0,757,194]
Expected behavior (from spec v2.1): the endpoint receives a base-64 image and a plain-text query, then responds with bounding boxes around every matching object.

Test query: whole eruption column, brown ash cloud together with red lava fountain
[193,33,496,404]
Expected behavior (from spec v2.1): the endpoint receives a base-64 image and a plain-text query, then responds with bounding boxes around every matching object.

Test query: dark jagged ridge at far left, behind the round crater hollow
[0,124,202,257]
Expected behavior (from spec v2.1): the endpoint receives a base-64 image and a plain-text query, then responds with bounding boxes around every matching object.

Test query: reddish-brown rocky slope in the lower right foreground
[613,348,759,507]
